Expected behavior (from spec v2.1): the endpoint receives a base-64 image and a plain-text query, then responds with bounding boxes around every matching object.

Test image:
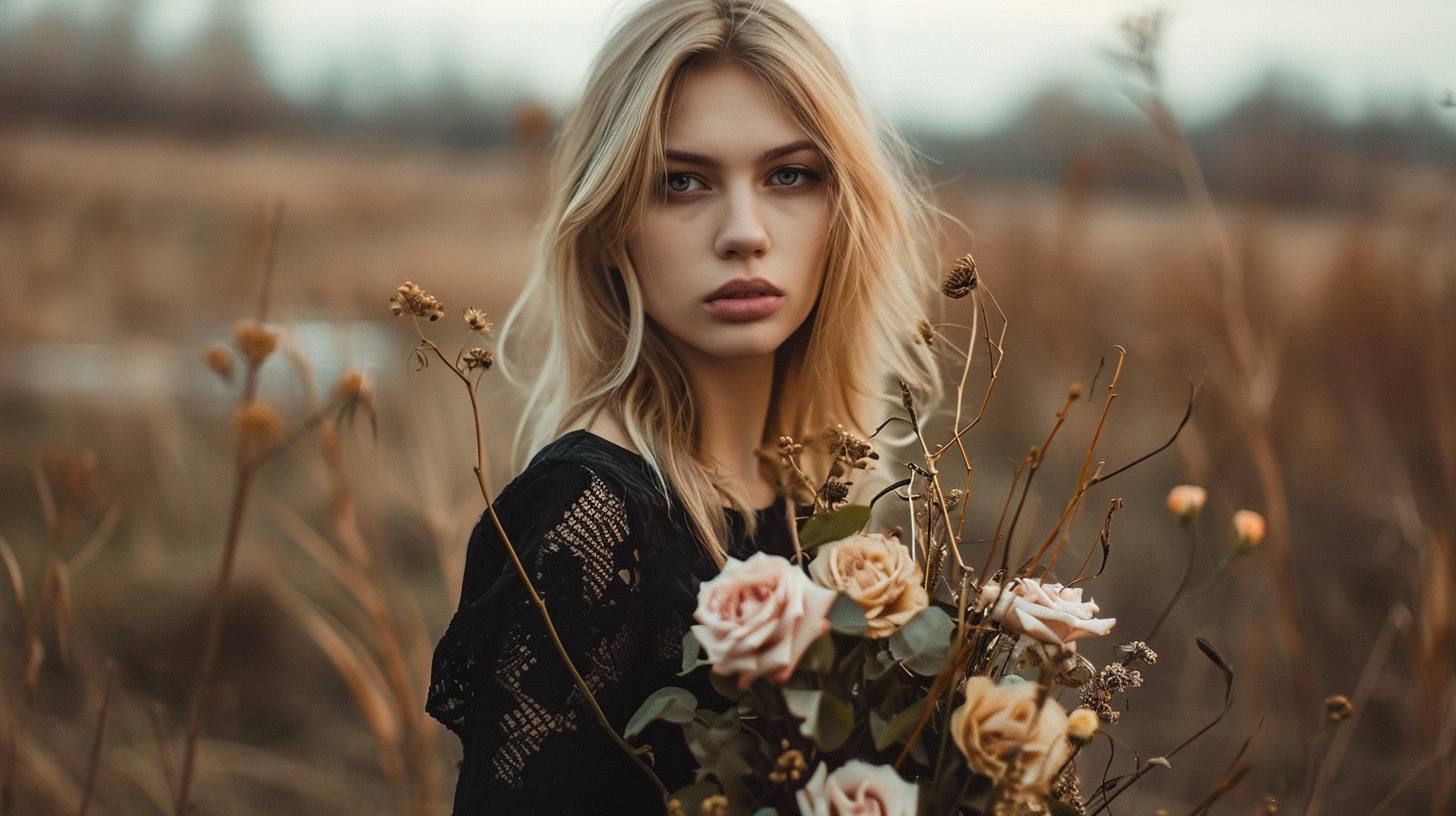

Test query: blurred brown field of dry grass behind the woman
[0,122,1456,816]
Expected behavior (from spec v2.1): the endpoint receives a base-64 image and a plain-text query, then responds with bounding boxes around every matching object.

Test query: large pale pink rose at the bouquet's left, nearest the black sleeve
[693,552,834,688]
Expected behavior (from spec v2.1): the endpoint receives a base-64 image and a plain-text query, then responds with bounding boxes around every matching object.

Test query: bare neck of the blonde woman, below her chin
[677,348,775,509]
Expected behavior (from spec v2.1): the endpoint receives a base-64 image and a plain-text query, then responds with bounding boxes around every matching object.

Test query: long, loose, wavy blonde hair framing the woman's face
[501,0,939,564]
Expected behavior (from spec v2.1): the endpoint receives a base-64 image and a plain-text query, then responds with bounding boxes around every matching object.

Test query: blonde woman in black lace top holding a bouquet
[428,0,938,813]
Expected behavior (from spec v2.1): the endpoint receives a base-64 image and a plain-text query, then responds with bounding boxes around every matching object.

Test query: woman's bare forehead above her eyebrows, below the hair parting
[662,63,810,157]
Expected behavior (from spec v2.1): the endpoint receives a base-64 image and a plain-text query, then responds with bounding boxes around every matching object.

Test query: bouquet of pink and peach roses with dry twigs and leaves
[625,256,1232,816]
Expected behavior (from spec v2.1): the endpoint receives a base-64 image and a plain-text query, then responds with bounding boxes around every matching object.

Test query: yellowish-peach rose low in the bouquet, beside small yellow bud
[951,676,1072,791]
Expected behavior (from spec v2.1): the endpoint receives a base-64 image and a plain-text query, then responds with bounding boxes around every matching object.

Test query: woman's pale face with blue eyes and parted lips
[628,64,830,363]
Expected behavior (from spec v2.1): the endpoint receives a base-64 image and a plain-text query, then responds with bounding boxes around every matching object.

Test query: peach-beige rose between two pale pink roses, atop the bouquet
[810,533,930,638]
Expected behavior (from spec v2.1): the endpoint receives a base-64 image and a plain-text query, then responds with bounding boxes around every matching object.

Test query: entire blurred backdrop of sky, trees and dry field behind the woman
[0,0,1456,815]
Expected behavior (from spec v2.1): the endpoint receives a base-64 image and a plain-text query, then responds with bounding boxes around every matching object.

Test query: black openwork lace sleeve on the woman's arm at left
[428,465,661,815]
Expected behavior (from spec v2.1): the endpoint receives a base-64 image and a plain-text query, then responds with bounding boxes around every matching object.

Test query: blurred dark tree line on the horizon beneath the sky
[0,0,1456,207]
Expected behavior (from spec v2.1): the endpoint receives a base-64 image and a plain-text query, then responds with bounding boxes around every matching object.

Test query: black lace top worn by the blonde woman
[425,431,792,816]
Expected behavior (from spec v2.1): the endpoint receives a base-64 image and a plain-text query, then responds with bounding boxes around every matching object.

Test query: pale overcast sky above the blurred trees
[9,0,1456,130]
